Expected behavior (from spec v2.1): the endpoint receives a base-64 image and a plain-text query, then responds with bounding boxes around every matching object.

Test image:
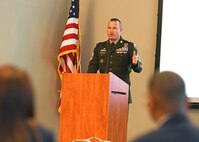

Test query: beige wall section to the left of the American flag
[0,0,69,140]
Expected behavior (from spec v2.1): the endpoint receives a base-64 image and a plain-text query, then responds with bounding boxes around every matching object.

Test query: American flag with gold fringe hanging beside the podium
[57,0,80,78]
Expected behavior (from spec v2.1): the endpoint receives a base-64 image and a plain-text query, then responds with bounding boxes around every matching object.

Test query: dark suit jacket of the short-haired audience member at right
[132,113,199,142]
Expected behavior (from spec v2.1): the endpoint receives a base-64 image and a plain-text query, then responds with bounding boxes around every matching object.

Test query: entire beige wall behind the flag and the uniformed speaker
[0,0,199,139]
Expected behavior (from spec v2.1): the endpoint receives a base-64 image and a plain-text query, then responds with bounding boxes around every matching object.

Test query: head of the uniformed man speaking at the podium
[107,18,122,42]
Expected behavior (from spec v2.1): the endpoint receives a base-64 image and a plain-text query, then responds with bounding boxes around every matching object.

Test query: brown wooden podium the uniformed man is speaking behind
[60,73,129,142]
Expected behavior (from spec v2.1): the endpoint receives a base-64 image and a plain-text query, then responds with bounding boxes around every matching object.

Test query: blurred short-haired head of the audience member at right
[148,72,188,121]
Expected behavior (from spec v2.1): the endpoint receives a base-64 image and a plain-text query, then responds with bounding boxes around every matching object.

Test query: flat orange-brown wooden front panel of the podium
[60,74,109,142]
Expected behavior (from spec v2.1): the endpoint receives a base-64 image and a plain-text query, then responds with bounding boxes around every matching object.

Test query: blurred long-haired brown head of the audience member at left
[0,65,34,124]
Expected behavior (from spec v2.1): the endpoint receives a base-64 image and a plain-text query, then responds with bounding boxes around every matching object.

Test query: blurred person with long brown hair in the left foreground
[0,65,54,142]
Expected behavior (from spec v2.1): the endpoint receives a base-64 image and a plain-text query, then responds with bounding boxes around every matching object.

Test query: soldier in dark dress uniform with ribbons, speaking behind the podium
[87,18,142,103]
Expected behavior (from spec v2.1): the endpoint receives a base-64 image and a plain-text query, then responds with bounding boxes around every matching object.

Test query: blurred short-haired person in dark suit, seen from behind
[134,72,199,142]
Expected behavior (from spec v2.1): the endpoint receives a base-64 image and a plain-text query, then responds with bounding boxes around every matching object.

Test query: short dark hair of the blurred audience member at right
[149,71,186,110]
